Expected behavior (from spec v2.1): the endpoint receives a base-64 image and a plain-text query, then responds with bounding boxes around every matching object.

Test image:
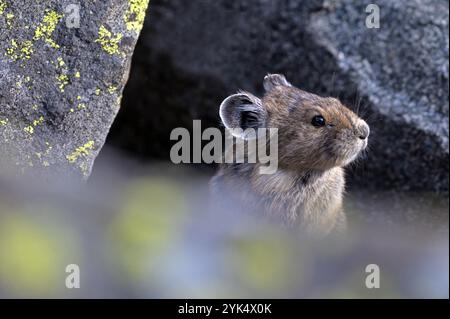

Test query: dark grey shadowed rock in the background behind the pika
[111,0,449,190]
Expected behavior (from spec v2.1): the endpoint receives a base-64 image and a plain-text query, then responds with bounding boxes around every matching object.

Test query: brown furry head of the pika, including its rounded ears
[220,74,370,170]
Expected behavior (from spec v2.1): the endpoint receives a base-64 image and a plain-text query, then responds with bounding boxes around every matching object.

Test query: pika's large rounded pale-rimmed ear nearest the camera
[219,92,267,138]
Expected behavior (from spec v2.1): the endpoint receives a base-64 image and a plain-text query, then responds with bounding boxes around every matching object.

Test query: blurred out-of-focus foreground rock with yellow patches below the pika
[0,156,449,299]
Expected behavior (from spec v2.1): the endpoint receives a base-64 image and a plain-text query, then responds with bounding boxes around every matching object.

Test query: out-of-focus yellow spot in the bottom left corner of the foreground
[0,210,76,297]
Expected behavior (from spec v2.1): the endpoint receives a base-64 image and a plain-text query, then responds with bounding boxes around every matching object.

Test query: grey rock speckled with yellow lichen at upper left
[0,0,148,177]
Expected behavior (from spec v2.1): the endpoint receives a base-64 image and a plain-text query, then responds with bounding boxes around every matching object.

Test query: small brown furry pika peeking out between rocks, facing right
[210,74,370,234]
